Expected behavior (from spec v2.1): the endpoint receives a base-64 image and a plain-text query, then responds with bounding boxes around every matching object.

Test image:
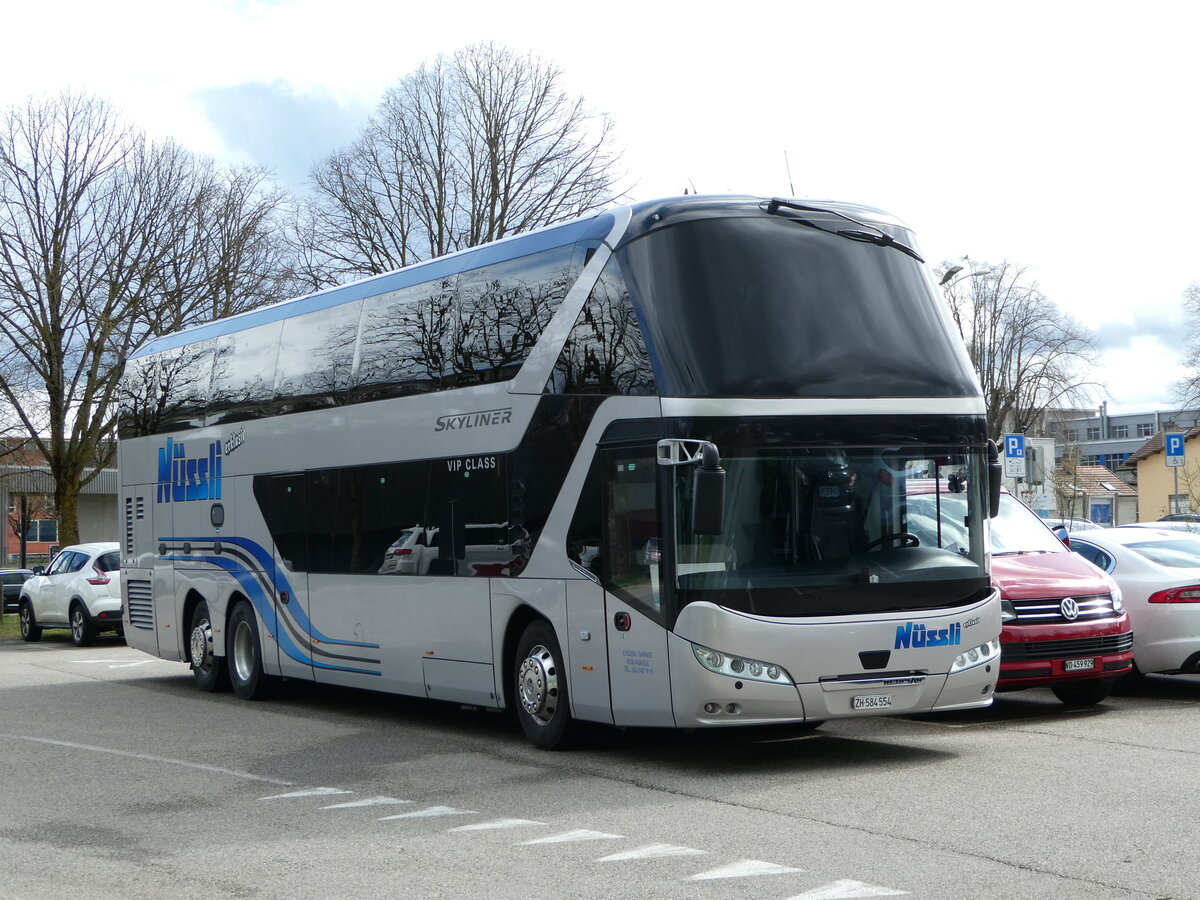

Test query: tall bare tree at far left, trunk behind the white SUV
[0,95,295,542]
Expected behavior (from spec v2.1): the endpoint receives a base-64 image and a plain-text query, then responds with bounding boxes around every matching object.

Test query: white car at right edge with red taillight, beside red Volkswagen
[1070,526,1200,674]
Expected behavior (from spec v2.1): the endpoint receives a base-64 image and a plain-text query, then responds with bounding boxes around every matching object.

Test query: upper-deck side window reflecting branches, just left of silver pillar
[450,246,575,384]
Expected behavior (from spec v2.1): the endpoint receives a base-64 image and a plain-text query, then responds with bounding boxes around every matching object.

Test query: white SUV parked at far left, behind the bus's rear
[17,541,124,647]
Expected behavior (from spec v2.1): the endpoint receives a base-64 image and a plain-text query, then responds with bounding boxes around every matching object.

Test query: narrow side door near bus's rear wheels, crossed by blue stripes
[254,473,312,680]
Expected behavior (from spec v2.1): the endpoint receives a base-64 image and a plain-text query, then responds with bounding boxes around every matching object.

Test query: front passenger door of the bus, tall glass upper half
[600,446,674,726]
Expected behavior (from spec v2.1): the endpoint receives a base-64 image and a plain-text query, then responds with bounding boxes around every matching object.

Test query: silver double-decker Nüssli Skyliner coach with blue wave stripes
[120,197,1001,748]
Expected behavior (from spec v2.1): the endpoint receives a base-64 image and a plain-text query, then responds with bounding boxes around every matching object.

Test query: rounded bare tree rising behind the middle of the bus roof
[294,43,618,284]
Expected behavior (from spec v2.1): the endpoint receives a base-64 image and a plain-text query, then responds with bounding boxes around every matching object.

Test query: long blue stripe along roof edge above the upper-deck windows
[132,212,614,359]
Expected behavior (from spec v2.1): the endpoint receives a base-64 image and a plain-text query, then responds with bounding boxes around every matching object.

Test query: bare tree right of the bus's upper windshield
[944,262,1099,434]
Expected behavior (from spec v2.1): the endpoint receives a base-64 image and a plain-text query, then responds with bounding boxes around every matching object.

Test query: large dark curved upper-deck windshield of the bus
[617,214,978,397]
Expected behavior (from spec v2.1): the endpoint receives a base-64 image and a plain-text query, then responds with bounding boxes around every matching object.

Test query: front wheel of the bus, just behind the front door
[512,619,575,750]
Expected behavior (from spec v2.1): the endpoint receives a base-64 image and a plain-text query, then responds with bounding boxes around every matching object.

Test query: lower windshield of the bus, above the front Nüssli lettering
[665,446,989,617]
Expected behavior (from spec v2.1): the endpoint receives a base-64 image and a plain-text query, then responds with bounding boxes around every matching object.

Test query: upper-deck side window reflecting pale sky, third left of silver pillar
[275,301,362,413]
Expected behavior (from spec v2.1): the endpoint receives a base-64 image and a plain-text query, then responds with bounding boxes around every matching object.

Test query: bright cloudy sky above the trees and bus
[0,0,1200,412]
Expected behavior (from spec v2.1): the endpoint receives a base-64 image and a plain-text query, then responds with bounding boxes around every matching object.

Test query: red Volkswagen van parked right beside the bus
[907,492,1134,706]
